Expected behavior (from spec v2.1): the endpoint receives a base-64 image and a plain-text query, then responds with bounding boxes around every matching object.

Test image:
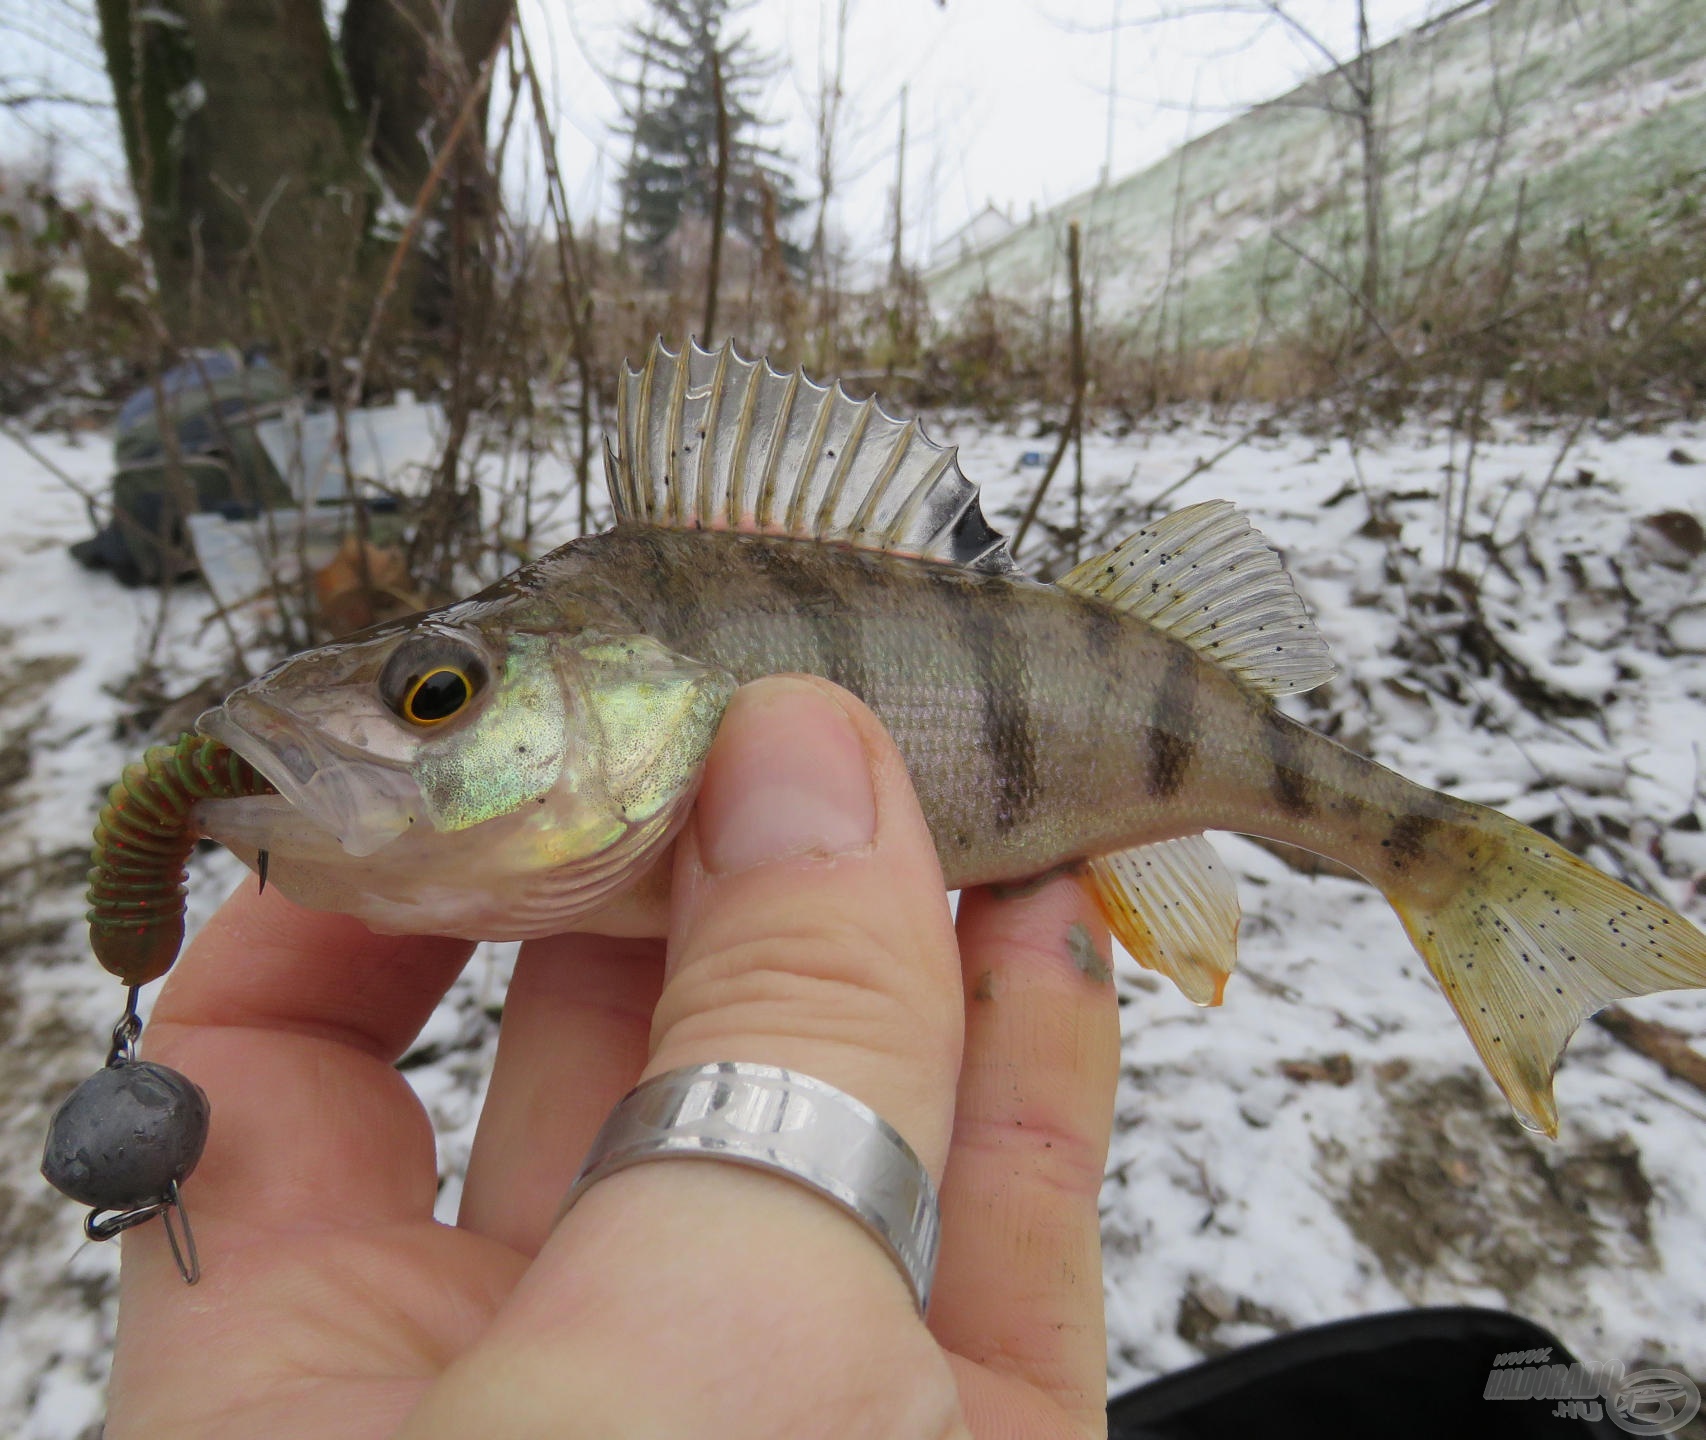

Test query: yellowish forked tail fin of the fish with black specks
[1387,810,1706,1135]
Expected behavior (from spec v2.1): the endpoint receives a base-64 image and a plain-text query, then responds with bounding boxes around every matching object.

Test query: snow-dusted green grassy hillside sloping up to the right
[925,0,1706,348]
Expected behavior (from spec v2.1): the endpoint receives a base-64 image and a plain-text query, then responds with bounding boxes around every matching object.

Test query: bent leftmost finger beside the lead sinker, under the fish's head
[145,887,471,1235]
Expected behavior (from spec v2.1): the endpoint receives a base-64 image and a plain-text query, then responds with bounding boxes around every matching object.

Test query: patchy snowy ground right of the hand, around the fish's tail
[954,407,1706,1387]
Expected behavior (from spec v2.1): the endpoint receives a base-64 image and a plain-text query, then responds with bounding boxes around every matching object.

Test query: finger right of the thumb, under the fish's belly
[930,877,1119,1430]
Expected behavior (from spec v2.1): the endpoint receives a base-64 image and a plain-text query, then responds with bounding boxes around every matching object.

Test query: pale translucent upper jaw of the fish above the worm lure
[196,694,425,856]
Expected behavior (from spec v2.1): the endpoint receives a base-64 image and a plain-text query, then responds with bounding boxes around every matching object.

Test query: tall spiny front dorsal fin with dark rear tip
[604,341,1015,575]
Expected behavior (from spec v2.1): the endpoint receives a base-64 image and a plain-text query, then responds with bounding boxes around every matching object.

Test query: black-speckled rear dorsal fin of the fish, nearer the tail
[1056,500,1336,694]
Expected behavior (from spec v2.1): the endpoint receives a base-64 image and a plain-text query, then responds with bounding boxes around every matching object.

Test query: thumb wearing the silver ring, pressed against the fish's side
[390,677,964,1437]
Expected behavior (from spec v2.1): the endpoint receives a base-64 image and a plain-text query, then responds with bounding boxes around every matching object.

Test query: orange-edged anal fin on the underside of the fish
[1085,834,1239,1005]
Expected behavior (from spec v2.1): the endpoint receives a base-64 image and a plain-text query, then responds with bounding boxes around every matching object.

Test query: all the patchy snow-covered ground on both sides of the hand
[0,399,1706,1440]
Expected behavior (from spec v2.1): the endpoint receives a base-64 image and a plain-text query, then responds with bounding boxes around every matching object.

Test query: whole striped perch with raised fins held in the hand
[166,341,1706,1135]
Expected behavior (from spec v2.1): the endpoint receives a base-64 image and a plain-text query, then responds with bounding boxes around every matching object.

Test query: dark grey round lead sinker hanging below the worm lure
[41,1060,208,1210]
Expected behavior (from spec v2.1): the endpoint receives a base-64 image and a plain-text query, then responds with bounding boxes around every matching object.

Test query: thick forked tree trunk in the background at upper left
[97,0,512,356]
